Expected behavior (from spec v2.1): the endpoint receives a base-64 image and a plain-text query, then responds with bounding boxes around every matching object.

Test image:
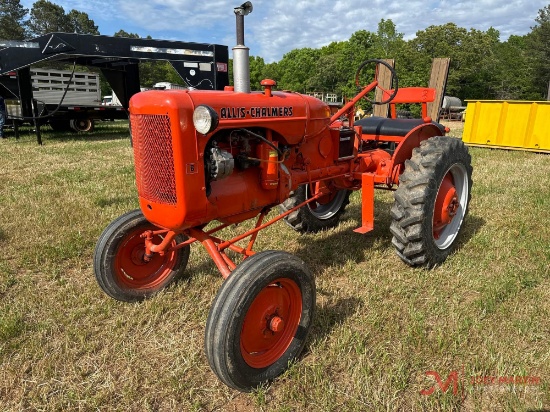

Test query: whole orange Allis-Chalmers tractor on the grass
[94,2,472,391]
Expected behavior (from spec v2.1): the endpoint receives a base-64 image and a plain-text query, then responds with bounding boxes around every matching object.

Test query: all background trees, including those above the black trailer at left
[0,0,550,100]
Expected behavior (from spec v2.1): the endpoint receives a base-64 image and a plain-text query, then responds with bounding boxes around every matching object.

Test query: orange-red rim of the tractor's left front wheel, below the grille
[114,227,177,289]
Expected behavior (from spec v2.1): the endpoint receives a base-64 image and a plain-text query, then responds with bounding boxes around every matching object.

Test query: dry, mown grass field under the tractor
[0,122,550,411]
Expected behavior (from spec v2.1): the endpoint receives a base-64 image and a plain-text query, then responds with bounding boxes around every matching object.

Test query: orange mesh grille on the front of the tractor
[130,115,177,205]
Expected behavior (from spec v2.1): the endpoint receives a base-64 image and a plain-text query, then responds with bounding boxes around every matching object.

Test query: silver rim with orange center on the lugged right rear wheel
[432,163,470,250]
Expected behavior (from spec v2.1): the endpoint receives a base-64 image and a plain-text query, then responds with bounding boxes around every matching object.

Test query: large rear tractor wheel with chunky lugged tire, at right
[390,136,472,267]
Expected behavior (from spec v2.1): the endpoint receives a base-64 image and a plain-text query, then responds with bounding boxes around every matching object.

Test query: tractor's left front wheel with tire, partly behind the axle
[94,209,190,302]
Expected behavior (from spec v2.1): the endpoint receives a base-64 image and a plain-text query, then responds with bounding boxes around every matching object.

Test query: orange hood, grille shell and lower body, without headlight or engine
[130,90,330,230]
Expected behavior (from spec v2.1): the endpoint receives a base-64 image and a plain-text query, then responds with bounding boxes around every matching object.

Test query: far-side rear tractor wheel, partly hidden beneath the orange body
[279,184,351,233]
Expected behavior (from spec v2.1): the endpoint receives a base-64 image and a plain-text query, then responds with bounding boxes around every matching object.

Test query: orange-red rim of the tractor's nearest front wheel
[241,278,302,369]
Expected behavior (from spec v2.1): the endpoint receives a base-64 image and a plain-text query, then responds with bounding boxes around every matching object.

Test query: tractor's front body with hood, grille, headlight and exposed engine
[130,86,338,230]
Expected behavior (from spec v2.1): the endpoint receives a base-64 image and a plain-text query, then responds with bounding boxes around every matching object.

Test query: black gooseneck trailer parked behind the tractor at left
[0,33,229,143]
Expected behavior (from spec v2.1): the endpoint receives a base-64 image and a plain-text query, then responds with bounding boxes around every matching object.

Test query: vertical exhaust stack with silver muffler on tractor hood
[233,1,252,93]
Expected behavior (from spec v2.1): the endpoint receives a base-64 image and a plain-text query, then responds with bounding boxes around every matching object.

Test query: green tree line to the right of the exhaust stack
[251,4,550,100]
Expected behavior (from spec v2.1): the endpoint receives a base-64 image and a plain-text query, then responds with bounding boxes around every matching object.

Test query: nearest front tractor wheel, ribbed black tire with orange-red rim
[205,250,315,392]
